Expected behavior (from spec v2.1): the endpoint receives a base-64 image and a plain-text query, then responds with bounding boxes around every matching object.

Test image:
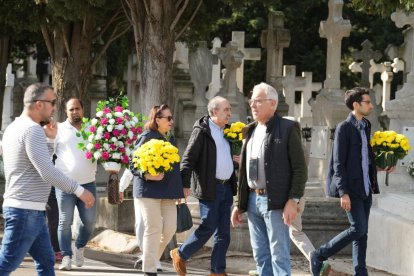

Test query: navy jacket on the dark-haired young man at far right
[326,112,379,198]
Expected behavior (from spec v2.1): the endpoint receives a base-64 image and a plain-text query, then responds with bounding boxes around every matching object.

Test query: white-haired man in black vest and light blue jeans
[231,83,307,276]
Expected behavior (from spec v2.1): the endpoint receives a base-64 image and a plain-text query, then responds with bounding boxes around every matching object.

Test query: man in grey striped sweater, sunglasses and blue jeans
[0,83,95,276]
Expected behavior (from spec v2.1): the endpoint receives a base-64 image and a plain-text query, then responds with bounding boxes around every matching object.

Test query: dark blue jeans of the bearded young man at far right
[315,194,372,275]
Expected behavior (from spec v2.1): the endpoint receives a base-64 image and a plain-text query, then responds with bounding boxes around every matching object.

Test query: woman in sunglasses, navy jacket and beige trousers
[131,105,188,276]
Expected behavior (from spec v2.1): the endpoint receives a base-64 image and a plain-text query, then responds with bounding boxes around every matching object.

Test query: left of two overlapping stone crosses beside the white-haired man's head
[282,65,306,117]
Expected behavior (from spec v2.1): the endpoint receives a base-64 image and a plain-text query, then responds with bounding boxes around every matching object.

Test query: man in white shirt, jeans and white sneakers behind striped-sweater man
[55,98,96,270]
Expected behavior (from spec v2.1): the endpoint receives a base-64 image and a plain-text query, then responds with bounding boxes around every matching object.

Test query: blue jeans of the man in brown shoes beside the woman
[178,183,233,273]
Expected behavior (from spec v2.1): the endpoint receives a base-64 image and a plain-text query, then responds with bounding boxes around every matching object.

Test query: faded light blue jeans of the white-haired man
[247,192,290,276]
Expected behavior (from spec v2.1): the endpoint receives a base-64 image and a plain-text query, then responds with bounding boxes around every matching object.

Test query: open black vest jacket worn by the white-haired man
[238,114,308,212]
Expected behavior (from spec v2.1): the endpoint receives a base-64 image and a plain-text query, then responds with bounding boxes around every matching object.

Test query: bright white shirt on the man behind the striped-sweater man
[55,120,96,184]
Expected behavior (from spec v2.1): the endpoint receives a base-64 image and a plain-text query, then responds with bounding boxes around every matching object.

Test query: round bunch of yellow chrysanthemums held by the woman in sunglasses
[132,139,180,176]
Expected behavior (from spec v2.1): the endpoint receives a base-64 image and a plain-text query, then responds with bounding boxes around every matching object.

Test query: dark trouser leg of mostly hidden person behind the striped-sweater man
[46,187,60,252]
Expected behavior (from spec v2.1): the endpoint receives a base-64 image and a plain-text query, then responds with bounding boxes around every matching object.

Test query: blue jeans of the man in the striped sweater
[0,207,55,276]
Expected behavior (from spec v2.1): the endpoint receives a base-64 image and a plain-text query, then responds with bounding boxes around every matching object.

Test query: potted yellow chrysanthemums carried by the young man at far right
[370,131,411,169]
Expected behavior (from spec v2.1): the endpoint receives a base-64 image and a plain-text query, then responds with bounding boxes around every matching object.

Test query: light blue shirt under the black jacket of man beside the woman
[208,119,234,180]
